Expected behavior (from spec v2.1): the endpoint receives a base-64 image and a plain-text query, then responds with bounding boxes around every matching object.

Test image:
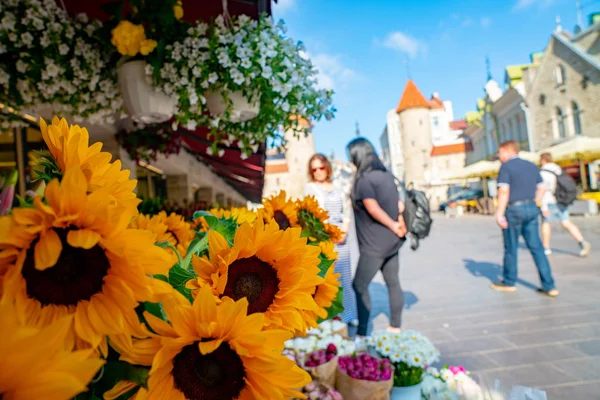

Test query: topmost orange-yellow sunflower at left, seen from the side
[40,117,138,201]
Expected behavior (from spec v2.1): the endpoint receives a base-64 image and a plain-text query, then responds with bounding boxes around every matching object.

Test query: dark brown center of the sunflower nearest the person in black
[223,256,279,314]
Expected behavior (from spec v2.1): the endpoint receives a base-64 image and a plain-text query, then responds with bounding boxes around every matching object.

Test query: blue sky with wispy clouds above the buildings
[273,0,600,159]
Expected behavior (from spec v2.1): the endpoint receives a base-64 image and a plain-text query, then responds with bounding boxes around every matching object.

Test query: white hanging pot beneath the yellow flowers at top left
[117,60,177,124]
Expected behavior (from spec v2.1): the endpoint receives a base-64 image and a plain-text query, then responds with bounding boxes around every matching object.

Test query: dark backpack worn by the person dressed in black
[402,181,433,250]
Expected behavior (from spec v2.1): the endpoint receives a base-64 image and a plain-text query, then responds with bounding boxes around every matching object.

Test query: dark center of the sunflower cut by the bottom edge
[172,342,246,400]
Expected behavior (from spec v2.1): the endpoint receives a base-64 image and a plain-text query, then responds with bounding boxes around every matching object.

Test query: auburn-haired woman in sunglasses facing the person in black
[304,154,358,324]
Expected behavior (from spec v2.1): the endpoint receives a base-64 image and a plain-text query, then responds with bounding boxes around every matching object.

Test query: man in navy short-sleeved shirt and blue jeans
[492,141,558,297]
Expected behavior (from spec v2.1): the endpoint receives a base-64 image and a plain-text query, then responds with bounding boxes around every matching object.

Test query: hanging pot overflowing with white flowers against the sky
[152,15,335,157]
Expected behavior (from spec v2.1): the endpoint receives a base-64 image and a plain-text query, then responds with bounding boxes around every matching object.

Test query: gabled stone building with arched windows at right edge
[525,22,600,149]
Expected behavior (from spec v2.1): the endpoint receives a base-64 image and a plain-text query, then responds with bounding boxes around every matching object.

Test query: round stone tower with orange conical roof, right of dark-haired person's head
[396,79,432,189]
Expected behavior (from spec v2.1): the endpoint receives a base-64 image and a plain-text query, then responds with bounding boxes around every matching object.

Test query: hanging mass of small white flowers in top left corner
[0,0,122,127]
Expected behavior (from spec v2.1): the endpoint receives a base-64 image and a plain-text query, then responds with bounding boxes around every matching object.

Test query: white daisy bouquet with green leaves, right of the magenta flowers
[369,331,440,386]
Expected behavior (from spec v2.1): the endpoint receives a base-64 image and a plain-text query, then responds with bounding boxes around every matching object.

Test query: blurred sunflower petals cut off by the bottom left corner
[0,298,104,400]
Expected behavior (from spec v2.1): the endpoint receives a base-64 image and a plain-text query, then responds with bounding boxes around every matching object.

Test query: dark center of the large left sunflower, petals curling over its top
[21,229,110,306]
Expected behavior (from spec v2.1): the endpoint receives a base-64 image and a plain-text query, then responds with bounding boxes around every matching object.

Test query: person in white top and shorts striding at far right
[540,153,591,257]
